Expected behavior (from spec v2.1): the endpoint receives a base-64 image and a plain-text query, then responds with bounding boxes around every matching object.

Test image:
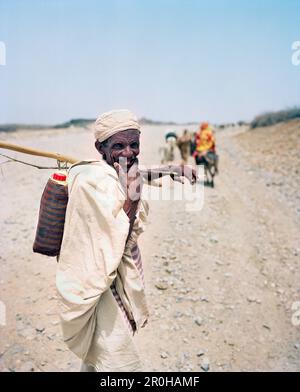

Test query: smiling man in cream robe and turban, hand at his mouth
[56,110,194,372]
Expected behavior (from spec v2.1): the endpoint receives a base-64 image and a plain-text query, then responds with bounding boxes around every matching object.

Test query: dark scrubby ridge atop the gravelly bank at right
[250,107,300,129]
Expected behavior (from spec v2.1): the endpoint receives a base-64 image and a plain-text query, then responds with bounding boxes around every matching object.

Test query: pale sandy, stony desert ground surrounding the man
[0,123,300,371]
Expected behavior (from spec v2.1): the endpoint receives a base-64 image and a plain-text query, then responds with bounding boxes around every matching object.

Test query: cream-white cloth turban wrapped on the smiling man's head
[94,110,140,142]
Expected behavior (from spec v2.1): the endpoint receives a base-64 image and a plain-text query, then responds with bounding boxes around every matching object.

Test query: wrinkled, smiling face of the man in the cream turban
[95,129,140,170]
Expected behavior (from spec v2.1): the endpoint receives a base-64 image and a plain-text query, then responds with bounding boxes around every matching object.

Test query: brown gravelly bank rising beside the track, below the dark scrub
[236,120,300,219]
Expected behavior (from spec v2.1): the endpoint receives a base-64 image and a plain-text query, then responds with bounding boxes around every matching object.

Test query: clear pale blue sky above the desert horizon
[0,0,300,124]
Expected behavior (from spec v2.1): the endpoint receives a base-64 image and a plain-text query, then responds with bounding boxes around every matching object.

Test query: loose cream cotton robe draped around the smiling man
[56,160,149,371]
